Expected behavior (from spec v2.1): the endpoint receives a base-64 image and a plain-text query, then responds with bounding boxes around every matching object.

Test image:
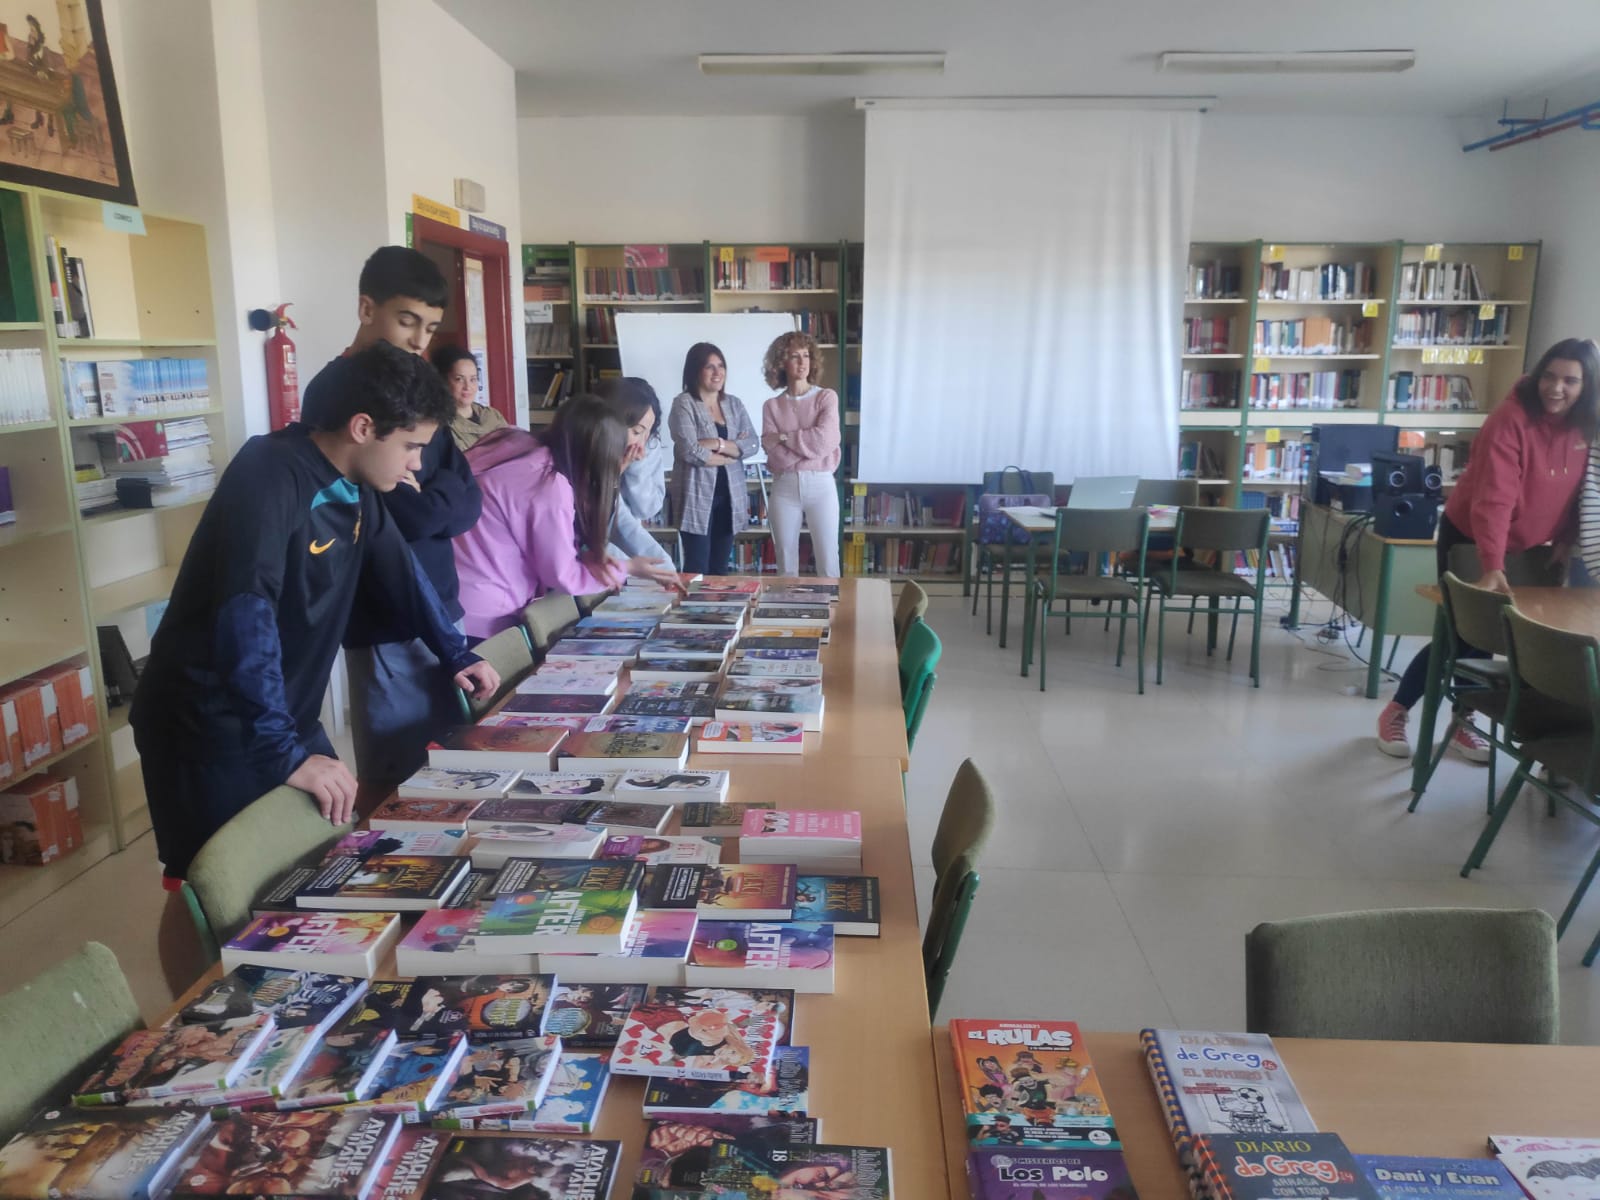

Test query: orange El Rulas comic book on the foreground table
[950,1018,1122,1150]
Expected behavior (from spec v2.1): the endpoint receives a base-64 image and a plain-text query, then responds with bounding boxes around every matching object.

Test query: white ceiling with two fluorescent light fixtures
[435,0,1600,117]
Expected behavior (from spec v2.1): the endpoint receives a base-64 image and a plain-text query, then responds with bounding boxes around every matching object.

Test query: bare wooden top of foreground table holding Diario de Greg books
[934,1026,1600,1200]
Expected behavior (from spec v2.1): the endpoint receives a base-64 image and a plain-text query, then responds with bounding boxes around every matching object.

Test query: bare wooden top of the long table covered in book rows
[162,579,949,1198]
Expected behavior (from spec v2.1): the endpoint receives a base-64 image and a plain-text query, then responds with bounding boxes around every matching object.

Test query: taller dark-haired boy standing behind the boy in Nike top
[301,246,482,810]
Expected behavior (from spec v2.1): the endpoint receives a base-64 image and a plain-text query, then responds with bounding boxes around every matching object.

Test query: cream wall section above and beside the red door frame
[378,0,528,424]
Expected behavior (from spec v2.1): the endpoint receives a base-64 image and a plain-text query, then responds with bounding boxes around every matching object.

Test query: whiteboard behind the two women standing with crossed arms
[616,312,795,462]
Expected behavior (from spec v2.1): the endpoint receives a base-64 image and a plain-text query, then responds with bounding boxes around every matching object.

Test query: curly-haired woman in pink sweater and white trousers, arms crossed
[762,333,838,579]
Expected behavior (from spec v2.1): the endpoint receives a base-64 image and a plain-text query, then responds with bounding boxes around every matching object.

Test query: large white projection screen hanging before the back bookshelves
[858,109,1200,483]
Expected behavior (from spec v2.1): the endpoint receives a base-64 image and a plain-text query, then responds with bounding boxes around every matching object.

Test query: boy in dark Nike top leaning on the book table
[131,342,499,878]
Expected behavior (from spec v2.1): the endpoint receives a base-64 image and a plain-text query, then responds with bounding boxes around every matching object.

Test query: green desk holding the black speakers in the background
[1290,504,1438,699]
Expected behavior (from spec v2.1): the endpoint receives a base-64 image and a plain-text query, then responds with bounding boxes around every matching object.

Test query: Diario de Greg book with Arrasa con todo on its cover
[1195,1133,1378,1200]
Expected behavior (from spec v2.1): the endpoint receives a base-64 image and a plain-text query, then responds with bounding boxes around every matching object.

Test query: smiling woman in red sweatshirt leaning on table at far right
[1378,338,1600,763]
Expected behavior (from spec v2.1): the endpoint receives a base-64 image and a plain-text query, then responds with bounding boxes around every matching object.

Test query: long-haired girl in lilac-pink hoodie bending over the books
[454,395,629,638]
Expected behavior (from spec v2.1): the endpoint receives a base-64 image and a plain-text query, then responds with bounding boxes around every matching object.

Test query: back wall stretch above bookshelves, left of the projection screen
[517,114,866,242]
